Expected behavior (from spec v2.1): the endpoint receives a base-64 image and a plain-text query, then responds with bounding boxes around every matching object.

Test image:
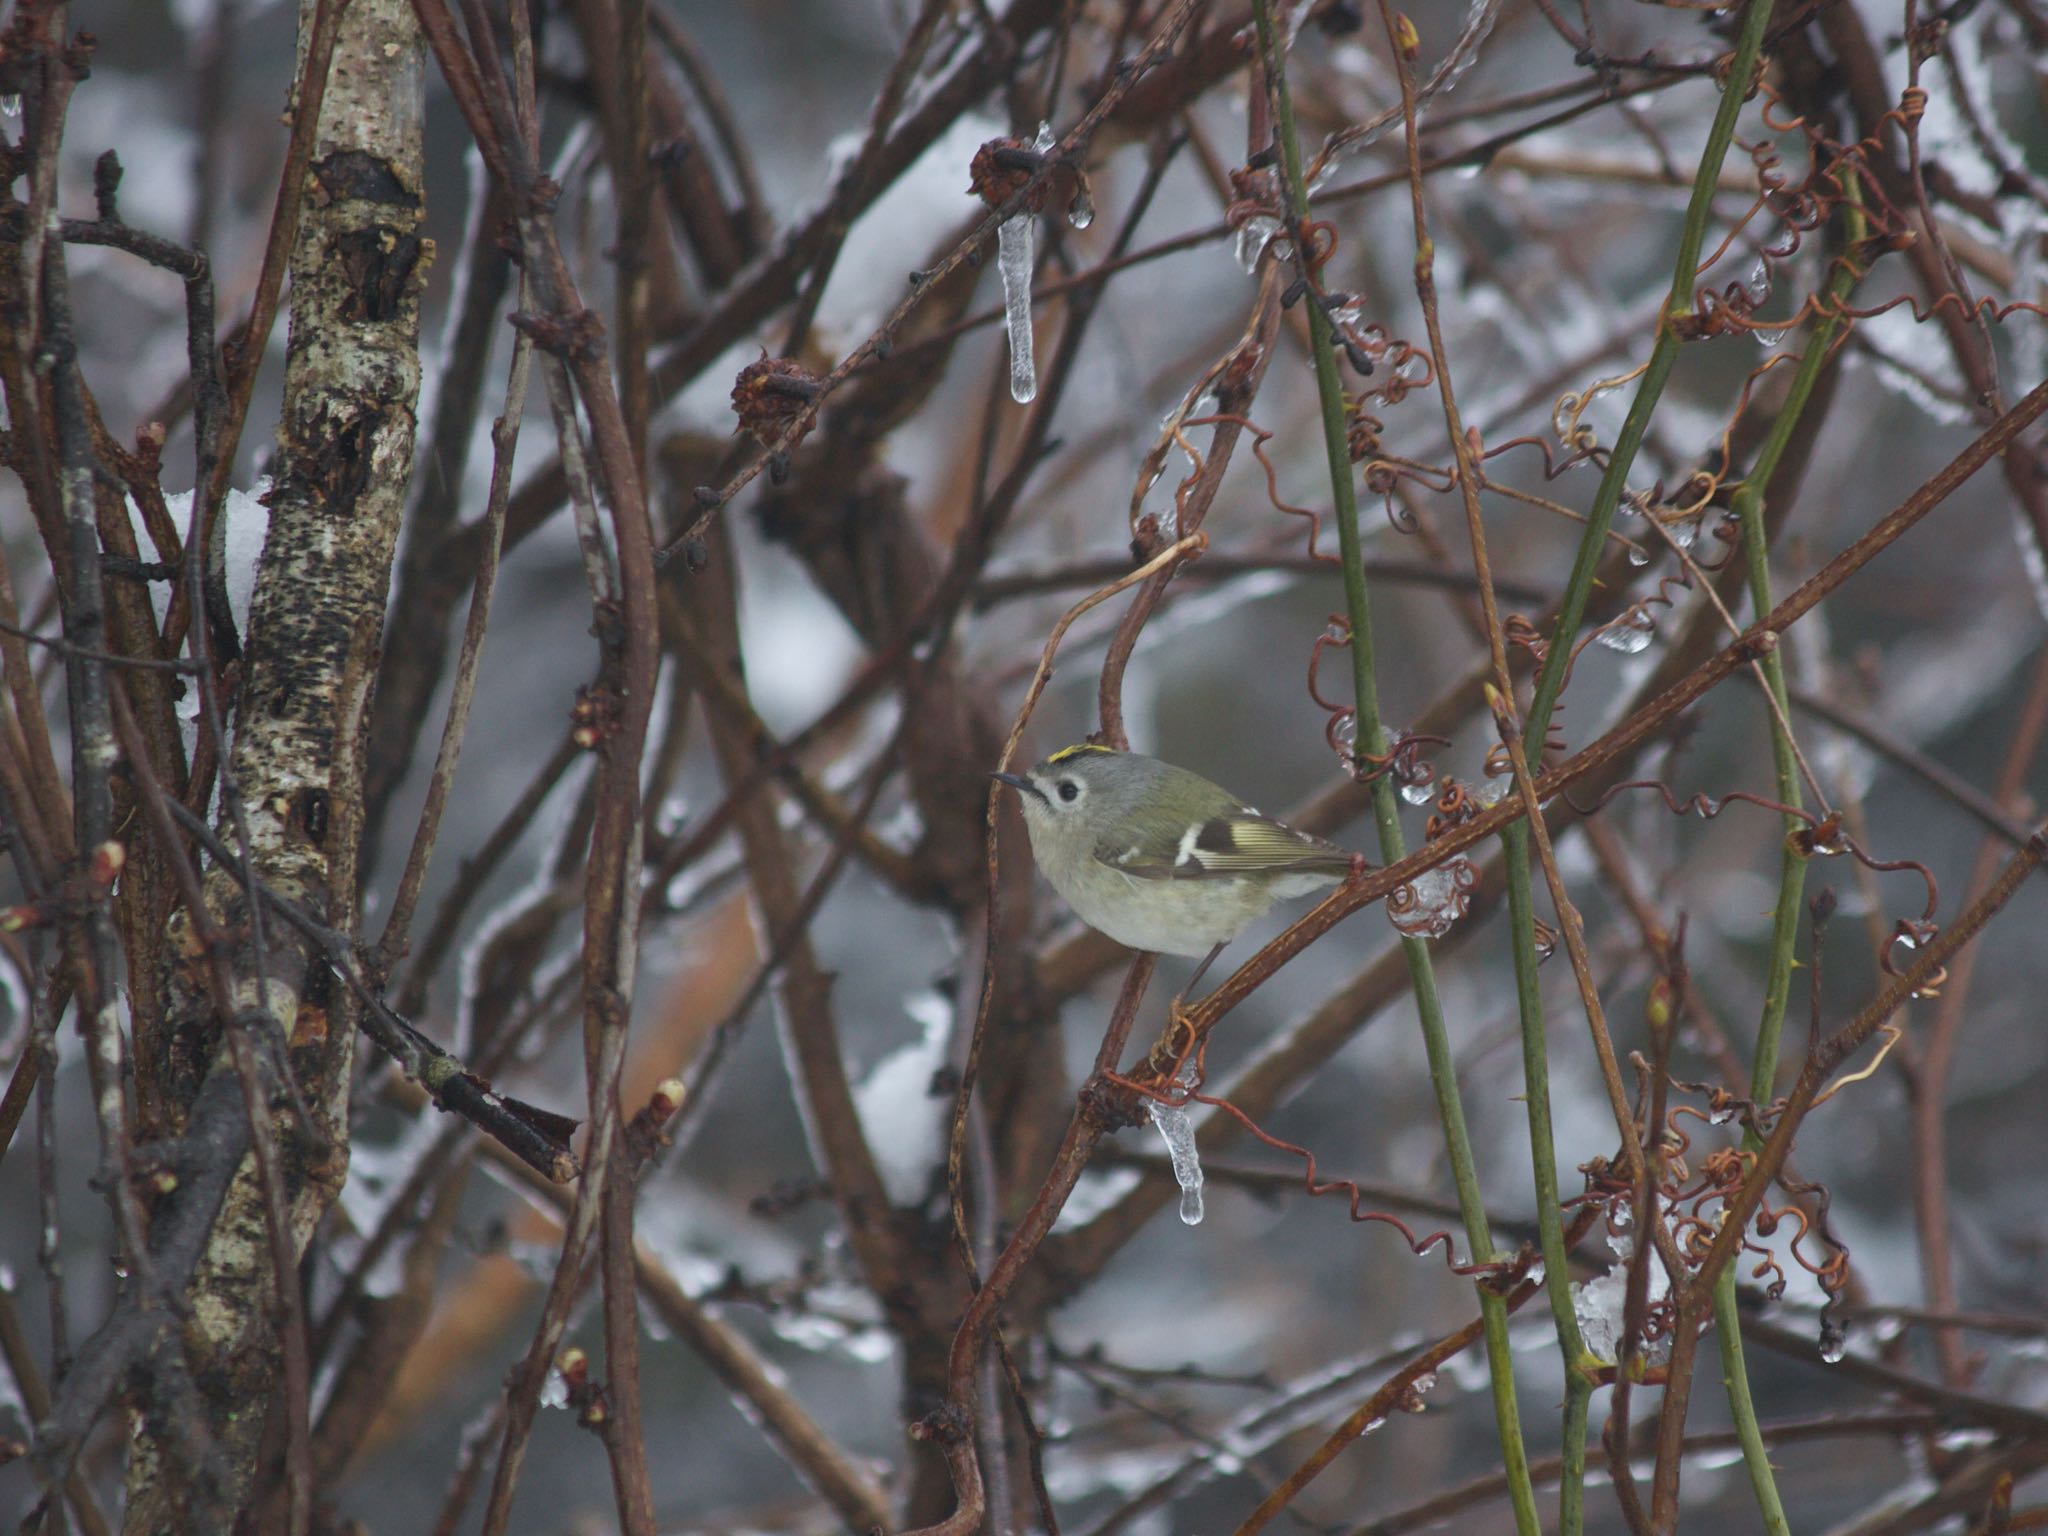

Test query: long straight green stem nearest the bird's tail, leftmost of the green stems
[1255,0,1542,1536]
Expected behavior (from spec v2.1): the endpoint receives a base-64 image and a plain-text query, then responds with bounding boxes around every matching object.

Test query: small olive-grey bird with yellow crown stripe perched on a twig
[991,743,1364,987]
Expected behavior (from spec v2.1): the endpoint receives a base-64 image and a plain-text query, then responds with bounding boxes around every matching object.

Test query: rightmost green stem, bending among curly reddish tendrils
[1714,174,1864,1536]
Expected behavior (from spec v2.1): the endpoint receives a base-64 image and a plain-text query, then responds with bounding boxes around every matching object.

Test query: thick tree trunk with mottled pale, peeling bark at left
[125,0,432,1532]
